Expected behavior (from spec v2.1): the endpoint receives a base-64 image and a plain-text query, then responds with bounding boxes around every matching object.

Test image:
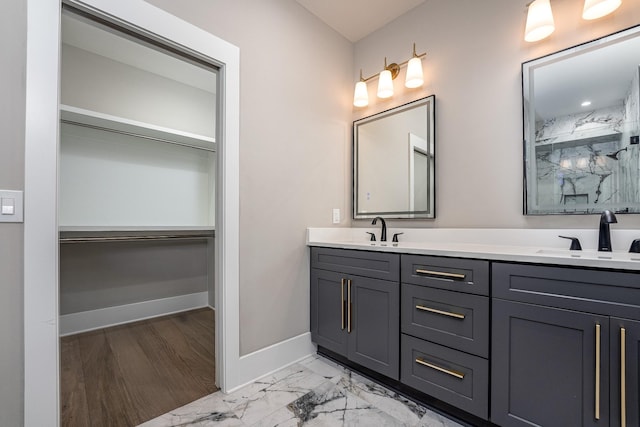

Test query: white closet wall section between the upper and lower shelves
[58,124,216,226]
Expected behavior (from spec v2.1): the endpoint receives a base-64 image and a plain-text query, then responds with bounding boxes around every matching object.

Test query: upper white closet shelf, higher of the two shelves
[60,104,216,151]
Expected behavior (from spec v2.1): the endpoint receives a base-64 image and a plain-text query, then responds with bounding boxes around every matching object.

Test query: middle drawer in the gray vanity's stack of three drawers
[401,283,489,357]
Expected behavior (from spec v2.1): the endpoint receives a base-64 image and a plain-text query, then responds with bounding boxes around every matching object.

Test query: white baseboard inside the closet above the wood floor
[59,292,209,336]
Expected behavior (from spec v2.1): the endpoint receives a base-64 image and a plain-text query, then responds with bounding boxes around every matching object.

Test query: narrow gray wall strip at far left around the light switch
[0,0,27,426]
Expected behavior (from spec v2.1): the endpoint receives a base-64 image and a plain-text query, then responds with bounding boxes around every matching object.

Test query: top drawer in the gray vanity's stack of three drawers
[401,255,489,295]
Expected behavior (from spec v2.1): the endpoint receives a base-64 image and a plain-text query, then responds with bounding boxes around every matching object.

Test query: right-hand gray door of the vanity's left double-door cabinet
[348,276,400,380]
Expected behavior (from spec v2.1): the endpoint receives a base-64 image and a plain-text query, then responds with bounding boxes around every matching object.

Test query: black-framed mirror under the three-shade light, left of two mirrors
[353,95,435,219]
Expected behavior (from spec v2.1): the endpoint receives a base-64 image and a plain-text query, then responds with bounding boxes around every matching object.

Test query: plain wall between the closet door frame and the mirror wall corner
[144,0,353,355]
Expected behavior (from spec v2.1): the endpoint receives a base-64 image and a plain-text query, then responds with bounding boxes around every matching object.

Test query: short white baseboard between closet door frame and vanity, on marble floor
[227,332,316,393]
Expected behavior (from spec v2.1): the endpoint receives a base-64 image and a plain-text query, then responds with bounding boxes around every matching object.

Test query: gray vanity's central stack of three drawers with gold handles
[400,255,489,419]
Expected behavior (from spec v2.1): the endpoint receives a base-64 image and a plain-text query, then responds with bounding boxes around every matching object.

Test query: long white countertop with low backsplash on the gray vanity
[307,227,640,271]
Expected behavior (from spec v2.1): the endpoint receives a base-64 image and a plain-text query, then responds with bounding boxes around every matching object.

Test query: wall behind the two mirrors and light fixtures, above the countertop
[352,0,640,228]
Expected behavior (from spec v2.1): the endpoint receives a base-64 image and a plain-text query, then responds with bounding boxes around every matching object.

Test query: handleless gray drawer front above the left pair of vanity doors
[311,246,400,282]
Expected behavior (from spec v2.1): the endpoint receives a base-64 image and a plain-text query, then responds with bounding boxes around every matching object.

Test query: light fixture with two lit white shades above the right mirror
[524,0,622,42]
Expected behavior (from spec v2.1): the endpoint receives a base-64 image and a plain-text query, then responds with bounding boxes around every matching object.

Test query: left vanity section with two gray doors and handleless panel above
[311,247,400,380]
